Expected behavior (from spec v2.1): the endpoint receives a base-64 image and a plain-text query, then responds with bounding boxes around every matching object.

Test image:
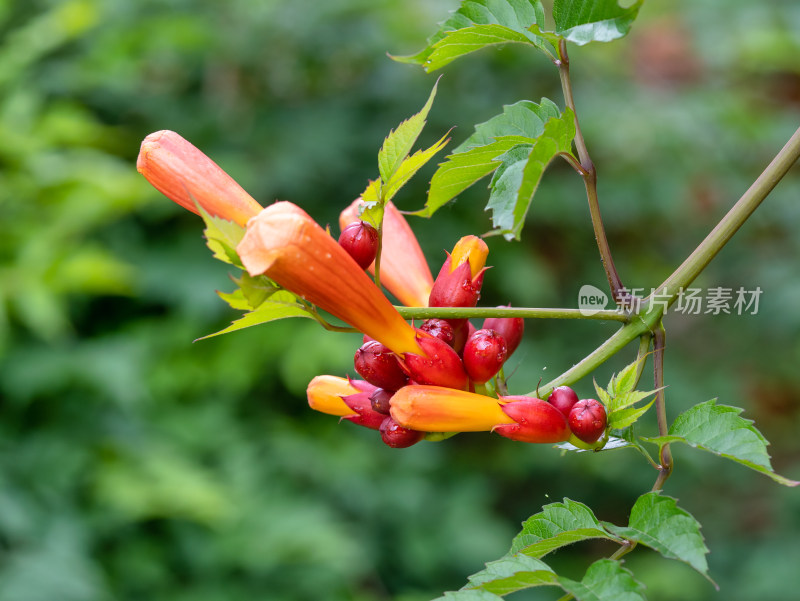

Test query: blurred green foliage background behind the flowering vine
[0,0,800,601]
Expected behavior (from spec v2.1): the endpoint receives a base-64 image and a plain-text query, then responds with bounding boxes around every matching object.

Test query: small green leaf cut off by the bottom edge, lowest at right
[558,559,645,601]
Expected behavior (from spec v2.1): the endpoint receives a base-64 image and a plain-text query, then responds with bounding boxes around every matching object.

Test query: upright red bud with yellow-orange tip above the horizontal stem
[428,236,489,307]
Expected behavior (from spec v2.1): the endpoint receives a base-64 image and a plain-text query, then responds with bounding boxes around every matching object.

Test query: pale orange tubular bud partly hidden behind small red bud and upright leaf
[339,198,433,307]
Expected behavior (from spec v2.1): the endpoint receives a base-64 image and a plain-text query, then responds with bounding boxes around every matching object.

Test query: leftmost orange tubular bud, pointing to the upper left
[136,130,261,226]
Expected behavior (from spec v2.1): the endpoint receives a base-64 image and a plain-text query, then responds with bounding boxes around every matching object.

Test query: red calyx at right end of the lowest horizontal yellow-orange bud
[494,396,570,442]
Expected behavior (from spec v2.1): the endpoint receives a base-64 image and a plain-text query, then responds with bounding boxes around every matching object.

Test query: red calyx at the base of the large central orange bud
[403,332,469,390]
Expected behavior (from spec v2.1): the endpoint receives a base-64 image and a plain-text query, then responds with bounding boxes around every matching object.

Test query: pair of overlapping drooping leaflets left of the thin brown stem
[418,98,575,239]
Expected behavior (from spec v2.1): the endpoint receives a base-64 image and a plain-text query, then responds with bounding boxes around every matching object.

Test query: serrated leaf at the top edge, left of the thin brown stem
[392,0,552,72]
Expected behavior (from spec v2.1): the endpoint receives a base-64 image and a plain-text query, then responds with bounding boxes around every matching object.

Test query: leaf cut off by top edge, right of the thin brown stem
[553,0,644,46]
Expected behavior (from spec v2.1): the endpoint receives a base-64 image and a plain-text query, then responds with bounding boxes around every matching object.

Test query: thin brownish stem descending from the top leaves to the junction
[556,39,626,304]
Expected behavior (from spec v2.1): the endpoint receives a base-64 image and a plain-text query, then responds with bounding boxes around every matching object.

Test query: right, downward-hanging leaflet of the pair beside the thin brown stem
[486,109,575,240]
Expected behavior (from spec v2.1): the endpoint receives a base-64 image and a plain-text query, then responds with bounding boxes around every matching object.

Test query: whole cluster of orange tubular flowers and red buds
[137,131,606,447]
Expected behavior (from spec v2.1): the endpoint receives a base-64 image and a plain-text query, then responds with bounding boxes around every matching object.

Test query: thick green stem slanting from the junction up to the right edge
[657,128,800,305]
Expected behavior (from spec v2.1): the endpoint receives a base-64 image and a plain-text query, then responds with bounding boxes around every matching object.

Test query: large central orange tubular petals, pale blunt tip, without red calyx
[236,201,422,353]
